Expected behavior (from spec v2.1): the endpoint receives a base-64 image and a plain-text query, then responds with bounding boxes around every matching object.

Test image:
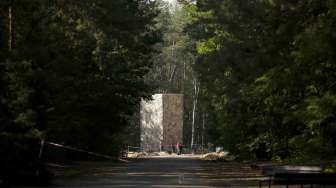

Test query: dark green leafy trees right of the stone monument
[189,0,336,160]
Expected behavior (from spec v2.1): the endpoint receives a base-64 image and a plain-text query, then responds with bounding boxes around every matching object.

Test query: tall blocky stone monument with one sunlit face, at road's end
[140,94,183,152]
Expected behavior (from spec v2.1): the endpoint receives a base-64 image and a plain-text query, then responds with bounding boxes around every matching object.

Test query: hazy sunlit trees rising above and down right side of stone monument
[146,1,209,145]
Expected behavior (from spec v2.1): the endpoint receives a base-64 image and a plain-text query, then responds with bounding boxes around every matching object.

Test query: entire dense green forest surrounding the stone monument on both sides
[0,0,336,185]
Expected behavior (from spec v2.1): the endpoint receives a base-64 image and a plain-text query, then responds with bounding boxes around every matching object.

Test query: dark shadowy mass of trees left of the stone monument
[0,0,160,158]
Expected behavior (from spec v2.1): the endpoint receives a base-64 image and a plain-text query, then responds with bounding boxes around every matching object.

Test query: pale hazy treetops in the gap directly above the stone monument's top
[147,2,194,93]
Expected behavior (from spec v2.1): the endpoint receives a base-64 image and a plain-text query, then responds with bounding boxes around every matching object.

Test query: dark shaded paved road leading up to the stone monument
[29,157,272,188]
